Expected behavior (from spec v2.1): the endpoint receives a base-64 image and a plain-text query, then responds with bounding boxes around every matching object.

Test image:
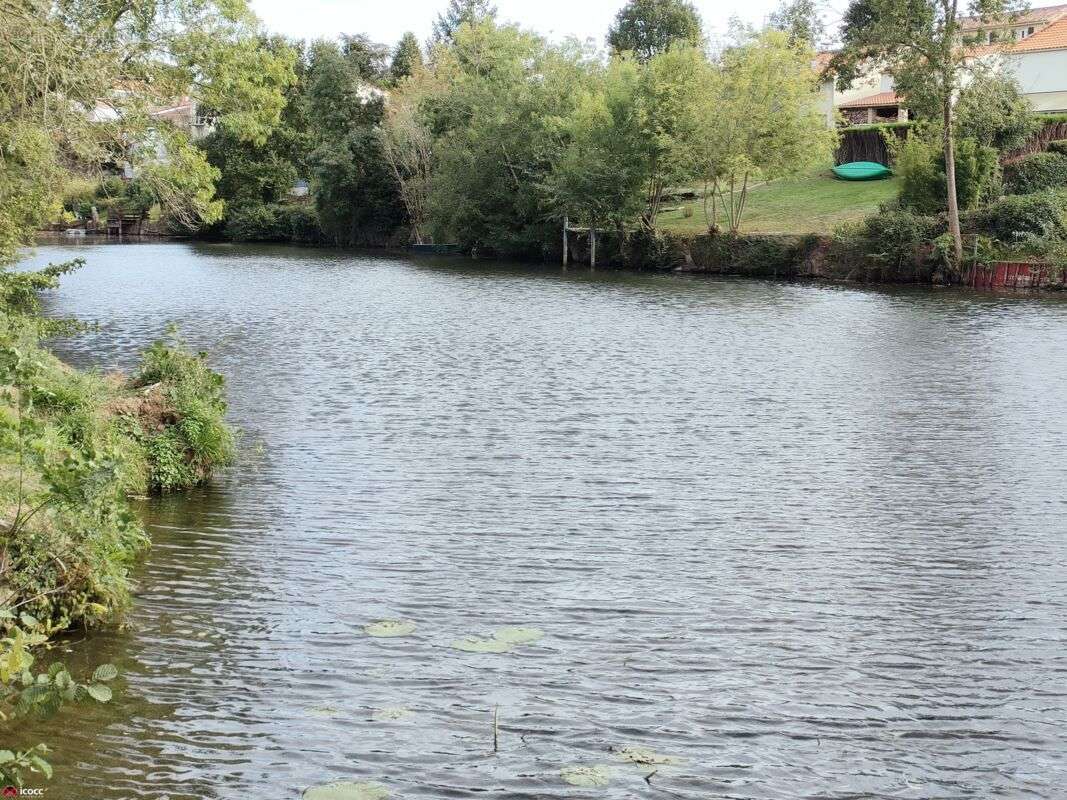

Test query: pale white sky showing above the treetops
[251,0,845,49]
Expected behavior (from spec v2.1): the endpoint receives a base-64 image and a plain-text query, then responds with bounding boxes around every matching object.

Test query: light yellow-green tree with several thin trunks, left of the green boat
[695,30,837,234]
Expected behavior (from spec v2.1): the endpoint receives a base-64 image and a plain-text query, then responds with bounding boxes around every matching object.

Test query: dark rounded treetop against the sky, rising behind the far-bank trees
[607,0,703,62]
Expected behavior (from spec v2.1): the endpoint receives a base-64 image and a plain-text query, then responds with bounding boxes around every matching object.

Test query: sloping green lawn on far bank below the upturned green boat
[659,170,899,234]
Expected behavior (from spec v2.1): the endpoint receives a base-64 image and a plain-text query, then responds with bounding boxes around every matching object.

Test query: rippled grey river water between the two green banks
[12,243,1067,800]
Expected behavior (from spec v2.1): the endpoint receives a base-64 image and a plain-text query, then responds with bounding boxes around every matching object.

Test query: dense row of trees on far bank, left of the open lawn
[189,0,834,258]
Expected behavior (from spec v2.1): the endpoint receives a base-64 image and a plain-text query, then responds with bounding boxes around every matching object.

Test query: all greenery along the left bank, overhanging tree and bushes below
[0,0,262,786]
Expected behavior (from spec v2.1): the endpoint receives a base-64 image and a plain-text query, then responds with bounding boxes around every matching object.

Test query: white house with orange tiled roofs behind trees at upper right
[814,4,1067,126]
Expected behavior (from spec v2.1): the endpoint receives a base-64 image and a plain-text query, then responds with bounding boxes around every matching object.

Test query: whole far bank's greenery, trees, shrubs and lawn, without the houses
[174,0,1067,281]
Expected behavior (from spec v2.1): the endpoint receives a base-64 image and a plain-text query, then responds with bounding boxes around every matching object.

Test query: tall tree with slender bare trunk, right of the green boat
[831,0,1019,268]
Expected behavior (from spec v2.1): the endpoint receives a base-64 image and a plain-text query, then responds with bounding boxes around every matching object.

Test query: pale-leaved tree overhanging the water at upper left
[0,0,294,241]
